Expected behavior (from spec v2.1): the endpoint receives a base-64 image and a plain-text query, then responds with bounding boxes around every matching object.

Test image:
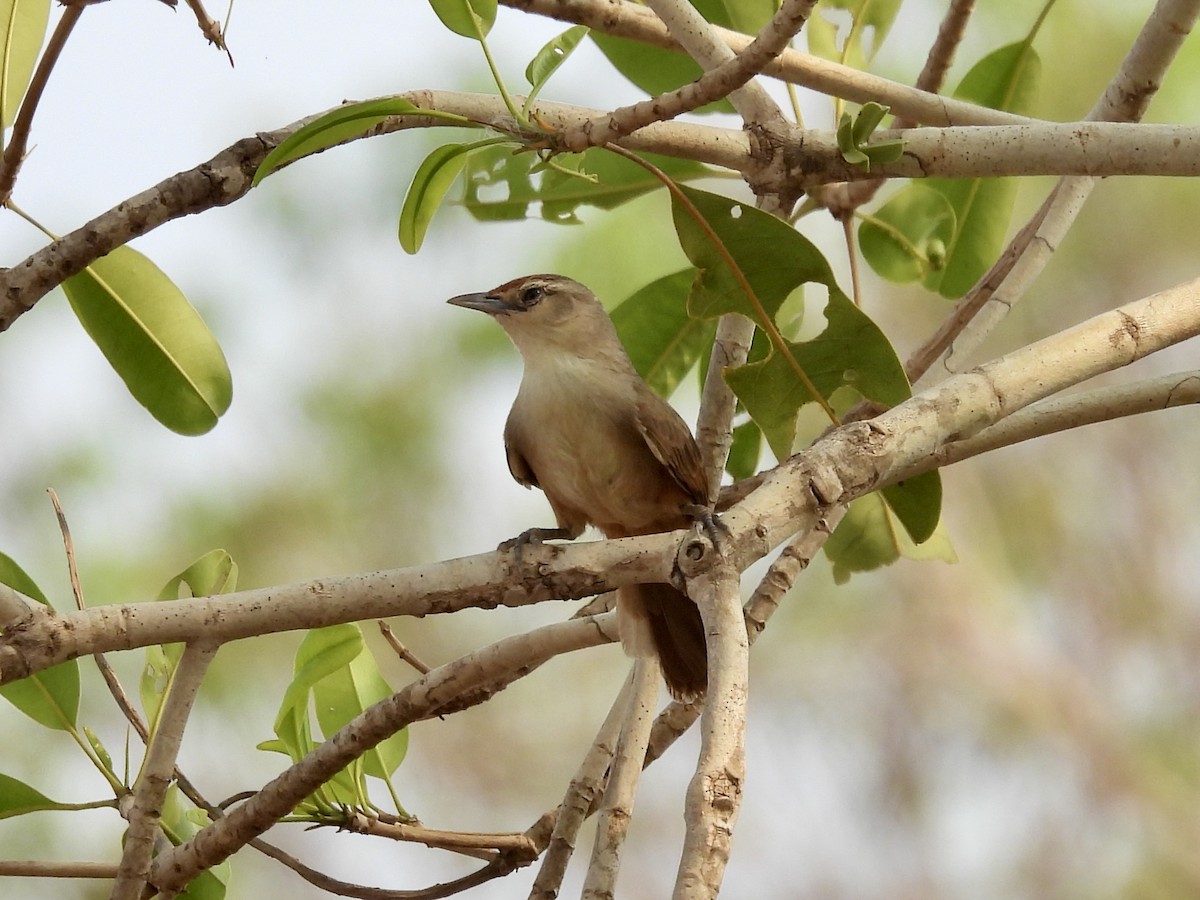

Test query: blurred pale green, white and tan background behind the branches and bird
[0,0,1200,900]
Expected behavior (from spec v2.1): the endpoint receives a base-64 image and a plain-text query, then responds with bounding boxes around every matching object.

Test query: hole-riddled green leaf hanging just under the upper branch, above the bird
[463,146,712,224]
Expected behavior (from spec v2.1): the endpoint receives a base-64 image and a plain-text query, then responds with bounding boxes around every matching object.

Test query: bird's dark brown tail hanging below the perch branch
[617,584,708,702]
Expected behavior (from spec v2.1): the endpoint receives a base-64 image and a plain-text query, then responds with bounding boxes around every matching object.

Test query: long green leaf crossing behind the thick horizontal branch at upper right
[925,41,1042,298]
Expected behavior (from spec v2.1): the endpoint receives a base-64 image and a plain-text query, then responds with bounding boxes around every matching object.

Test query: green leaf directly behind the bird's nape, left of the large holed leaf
[612,269,715,397]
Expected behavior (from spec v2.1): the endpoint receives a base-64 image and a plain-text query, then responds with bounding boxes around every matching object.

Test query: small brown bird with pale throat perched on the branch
[448,275,709,700]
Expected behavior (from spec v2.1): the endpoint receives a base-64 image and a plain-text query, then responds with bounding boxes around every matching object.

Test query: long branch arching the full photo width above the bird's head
[0,85,1200,331]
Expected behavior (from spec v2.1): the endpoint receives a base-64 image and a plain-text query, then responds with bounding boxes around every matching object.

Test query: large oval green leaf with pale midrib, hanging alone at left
[62,247,233,434]
